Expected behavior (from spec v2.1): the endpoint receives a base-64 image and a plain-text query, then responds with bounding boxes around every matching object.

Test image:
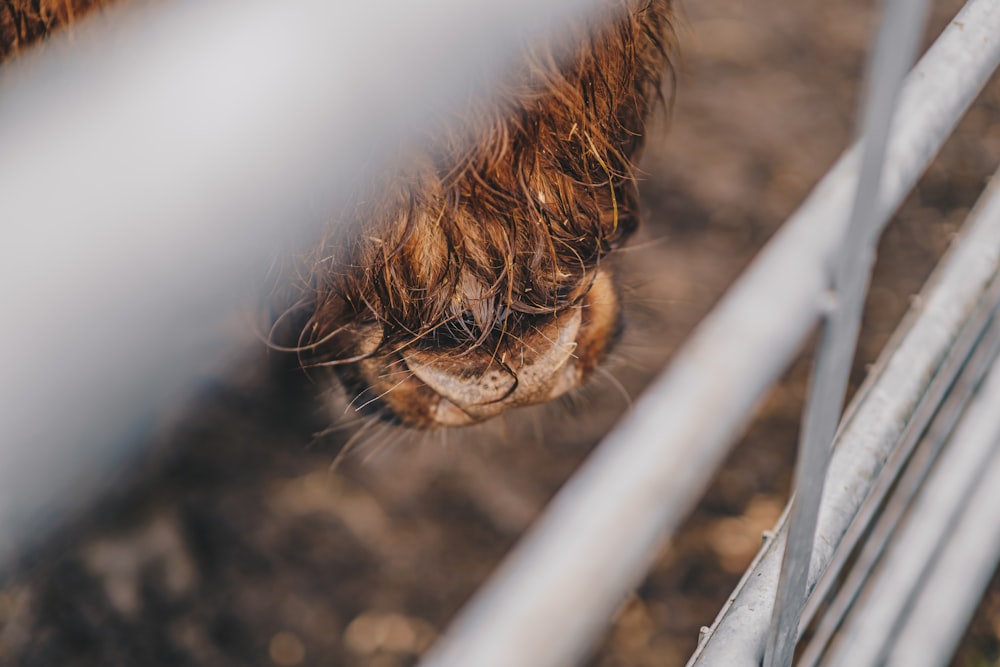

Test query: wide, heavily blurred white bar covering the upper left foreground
[0,0,593,560]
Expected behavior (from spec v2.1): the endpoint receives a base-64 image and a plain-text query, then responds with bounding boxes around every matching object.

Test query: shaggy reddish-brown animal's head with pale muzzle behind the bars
[0,0,673,428]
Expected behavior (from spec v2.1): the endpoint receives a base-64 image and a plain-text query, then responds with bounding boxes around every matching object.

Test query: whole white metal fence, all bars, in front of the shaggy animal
[0,0,1000,667]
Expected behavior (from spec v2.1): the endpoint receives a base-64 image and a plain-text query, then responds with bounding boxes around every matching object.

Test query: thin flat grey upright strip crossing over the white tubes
[764,0,927,667]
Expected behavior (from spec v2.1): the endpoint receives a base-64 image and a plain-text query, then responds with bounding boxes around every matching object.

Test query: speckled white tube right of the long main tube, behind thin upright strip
[688,111,1000,667]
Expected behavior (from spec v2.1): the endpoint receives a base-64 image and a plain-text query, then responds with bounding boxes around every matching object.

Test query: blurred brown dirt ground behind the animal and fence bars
[0,0,1000,667]
